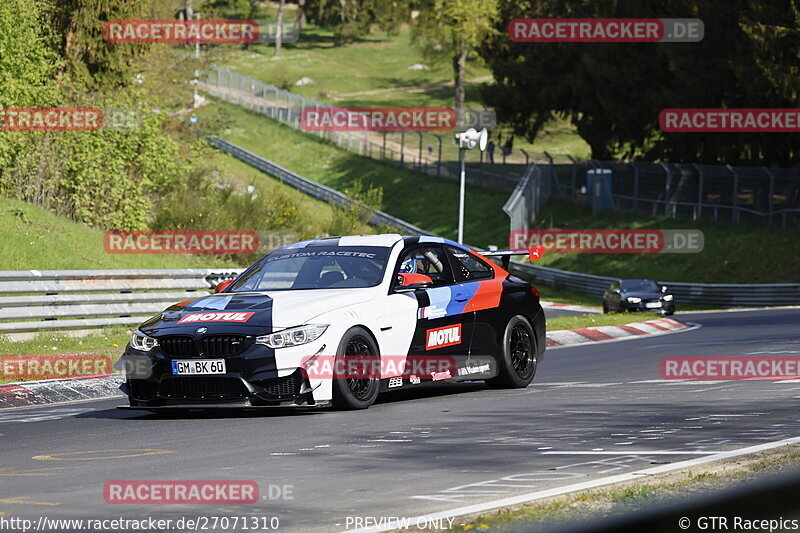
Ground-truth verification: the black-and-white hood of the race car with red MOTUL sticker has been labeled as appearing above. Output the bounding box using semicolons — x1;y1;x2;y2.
139;288;375;335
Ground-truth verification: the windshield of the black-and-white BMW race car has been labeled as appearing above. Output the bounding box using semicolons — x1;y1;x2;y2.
226;246;391;292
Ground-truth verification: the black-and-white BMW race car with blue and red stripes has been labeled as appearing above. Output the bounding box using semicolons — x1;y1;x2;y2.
122;235;546;410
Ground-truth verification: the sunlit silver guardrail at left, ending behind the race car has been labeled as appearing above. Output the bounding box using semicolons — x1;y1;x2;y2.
0;268;242;339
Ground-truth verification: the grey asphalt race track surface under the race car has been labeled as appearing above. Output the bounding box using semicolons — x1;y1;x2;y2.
0;309;800;531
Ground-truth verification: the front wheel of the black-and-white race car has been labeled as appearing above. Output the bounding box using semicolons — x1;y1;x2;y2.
332;327;380;411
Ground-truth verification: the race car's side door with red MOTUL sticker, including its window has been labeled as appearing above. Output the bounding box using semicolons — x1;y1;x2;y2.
396;244;474;355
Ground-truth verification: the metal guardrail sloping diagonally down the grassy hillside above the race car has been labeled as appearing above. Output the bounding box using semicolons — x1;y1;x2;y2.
207;137;433;235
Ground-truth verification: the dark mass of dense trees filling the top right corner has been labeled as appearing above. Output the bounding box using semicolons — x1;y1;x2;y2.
480;0;800;164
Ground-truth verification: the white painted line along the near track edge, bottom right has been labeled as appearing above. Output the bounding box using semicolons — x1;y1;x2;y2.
346;437;800;533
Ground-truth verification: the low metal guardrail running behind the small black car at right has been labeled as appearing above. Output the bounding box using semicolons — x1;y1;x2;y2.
511;261;800;307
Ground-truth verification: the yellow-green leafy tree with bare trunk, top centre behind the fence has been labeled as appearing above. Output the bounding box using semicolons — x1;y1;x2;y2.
412;0;497;122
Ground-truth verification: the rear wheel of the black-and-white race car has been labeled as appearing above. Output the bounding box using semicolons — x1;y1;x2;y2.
486;315;538;389
